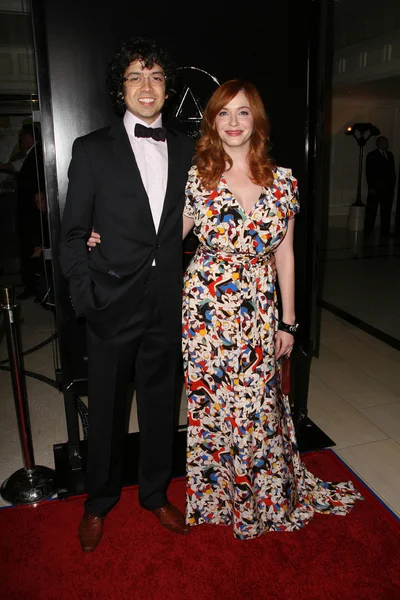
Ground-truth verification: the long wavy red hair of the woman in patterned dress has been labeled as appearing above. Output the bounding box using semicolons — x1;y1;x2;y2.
196;79;274;190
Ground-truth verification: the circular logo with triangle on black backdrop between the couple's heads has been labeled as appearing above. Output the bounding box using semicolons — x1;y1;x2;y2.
168;67;220;139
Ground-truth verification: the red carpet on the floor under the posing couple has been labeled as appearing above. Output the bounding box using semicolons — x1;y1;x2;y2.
0;450;400;600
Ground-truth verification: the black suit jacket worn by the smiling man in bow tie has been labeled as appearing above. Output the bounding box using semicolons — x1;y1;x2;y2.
60;121;193;341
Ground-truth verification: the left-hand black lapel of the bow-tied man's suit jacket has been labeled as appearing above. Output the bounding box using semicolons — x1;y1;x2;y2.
110;120;155;233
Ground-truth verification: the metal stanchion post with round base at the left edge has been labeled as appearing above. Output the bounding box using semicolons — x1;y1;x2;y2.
0;287;57;504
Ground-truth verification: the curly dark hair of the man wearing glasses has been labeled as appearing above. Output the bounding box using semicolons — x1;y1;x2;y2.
107;38;176;115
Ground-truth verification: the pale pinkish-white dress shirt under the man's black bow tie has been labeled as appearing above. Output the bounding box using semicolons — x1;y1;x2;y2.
124;111;168;233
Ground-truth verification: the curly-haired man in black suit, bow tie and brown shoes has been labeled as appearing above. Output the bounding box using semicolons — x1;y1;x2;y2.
60;39;193;551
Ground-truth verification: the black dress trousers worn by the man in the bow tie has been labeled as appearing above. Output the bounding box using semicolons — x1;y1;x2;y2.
85;267;181;515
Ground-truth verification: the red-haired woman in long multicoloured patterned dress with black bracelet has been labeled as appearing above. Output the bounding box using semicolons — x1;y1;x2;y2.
183;80;361;539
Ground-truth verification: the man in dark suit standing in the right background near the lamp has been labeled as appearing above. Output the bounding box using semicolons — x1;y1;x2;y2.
364;136;396;243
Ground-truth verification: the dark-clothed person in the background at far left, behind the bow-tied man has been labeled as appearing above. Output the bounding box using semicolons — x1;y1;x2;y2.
16;125;48;299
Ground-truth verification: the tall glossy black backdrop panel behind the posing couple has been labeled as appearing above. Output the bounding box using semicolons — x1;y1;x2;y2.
32;0;326;424
